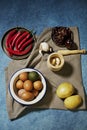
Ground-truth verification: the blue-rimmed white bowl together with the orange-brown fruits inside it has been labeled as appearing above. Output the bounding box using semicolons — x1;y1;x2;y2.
9;68;46;105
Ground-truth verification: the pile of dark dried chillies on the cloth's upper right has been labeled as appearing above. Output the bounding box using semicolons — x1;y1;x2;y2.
51;26;74;49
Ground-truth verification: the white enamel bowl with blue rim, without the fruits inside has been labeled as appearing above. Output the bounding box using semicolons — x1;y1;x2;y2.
9;68;46;105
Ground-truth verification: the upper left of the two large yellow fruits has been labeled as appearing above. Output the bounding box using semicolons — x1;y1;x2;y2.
56;82;75;98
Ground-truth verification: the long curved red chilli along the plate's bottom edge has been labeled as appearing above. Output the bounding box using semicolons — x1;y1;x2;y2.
6;44;33;56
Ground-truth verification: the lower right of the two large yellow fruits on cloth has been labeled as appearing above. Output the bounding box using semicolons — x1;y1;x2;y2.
64;95;82;110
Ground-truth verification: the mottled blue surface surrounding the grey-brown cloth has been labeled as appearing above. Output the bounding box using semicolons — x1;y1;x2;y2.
0;0;87;130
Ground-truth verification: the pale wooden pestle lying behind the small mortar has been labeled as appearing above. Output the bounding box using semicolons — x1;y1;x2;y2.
57;49;87;56
